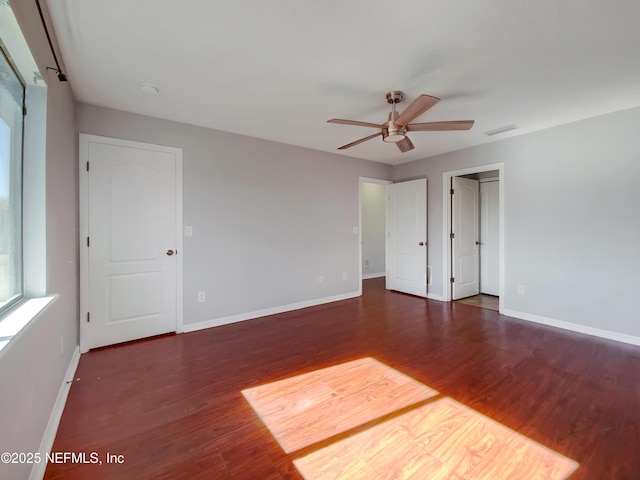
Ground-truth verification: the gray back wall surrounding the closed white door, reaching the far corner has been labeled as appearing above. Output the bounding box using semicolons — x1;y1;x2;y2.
76;104;391;325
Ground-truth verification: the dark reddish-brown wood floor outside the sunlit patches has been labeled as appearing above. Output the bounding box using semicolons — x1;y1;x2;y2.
45;279;640;480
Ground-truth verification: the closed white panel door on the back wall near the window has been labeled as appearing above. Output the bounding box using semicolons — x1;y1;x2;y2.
80;136;182;348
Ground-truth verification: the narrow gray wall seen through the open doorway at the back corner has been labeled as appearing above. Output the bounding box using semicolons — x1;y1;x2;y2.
360;183;387;276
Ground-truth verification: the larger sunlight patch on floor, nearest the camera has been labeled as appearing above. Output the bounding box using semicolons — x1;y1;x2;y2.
293;398;578;480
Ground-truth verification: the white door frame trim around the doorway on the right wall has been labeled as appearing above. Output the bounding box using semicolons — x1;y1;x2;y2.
442;162;505;313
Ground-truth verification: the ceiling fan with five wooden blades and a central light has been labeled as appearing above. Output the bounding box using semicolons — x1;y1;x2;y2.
327;90;474;153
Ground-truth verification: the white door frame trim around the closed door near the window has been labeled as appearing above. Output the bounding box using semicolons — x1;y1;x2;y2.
78;133;184;353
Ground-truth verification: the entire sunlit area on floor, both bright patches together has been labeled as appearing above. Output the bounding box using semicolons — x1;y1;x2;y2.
242;357;579;480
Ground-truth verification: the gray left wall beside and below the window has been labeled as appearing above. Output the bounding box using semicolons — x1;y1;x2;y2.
0;0;78;479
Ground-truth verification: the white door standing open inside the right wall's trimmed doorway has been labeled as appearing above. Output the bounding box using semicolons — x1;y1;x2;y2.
451;177;480;300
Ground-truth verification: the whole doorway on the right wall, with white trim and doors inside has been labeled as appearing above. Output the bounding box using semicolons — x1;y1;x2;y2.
443;164;504;311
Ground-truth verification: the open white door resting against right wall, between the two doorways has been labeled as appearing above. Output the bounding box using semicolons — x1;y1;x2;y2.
386;179;427;297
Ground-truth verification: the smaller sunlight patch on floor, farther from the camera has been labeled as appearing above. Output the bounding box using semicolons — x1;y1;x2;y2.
242;357;438;453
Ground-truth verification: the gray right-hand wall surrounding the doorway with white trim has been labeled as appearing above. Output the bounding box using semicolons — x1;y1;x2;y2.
394;108;640;337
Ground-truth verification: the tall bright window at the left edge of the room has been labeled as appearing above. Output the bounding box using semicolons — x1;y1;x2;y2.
0;46;25;312
